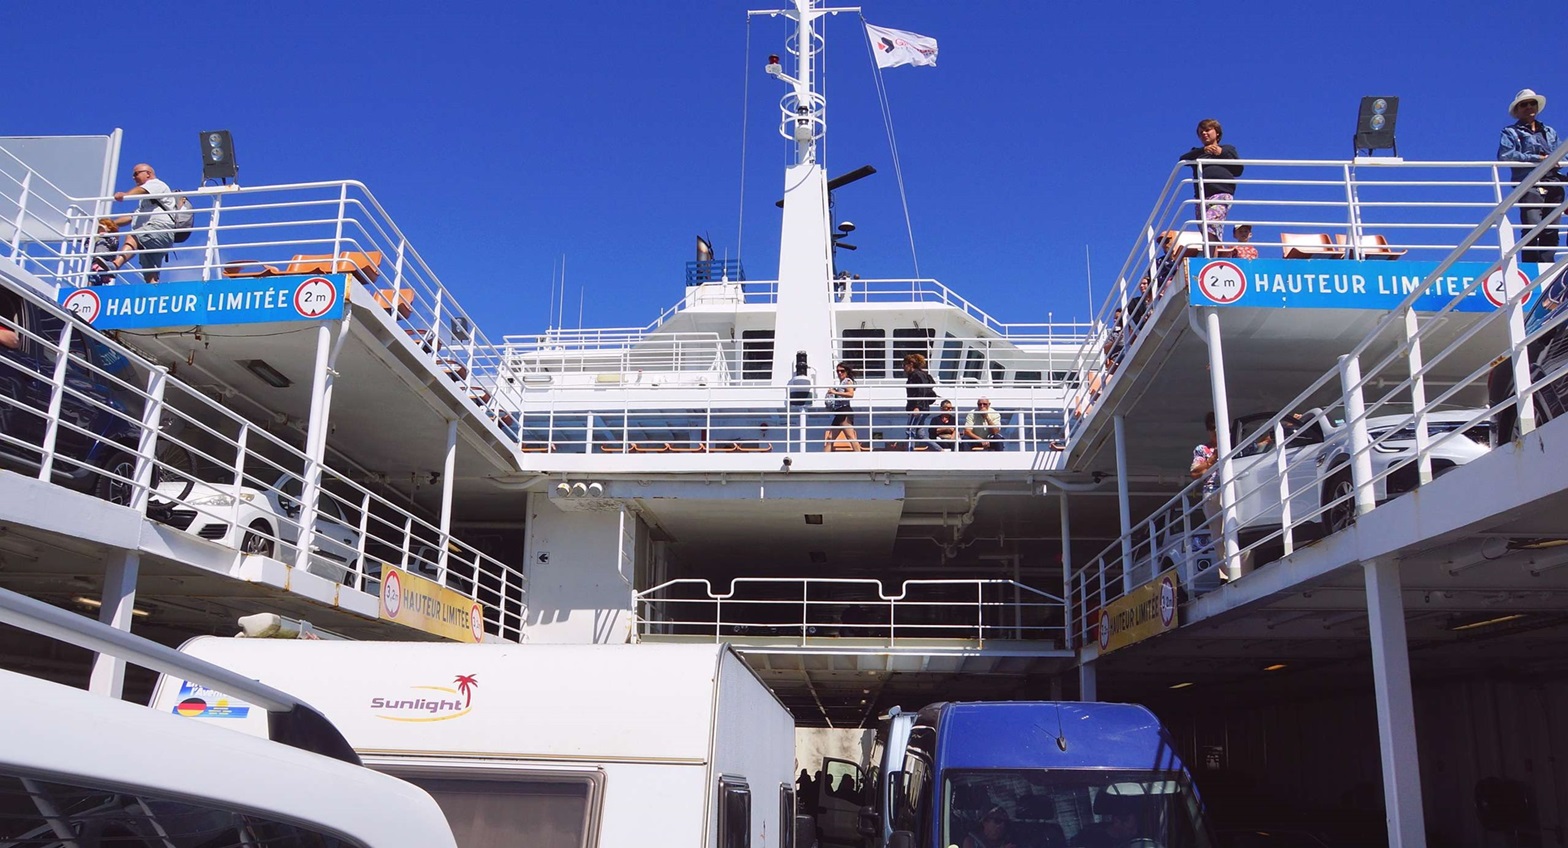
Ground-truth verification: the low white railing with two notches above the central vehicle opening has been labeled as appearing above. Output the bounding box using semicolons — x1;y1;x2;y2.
637;577;1065;647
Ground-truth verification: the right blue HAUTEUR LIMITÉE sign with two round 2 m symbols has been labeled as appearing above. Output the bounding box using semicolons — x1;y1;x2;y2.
1187;259;1537;312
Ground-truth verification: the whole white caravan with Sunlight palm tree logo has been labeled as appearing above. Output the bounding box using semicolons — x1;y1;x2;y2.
154;636;795;848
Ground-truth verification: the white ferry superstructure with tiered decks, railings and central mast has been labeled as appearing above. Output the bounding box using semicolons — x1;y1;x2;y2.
0;0;1568;845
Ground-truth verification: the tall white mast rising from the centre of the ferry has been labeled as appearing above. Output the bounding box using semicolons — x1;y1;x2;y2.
751;0;859;384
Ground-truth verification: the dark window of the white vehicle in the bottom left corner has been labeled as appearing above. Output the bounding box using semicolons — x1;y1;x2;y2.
0;774;370;848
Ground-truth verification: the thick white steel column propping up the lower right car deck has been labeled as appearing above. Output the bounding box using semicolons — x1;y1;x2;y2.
1363;561;1427;848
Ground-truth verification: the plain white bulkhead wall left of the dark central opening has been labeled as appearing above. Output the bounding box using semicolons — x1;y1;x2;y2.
524;492;652;644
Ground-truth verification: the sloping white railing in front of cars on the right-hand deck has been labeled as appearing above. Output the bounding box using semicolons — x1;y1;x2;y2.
1069;144;1568;644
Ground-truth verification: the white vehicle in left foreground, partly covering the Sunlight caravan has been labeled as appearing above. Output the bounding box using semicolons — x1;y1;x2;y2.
0;589;456;848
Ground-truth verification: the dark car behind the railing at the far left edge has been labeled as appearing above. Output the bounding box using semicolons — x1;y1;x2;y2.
0;287;143;505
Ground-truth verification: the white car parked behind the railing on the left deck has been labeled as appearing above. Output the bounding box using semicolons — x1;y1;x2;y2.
149;473;359;583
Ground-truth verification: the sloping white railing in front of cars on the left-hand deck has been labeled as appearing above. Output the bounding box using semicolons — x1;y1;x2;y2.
0;274;525;641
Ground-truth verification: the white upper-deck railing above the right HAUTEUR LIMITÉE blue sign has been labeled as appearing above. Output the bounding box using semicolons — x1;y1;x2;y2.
1068;160;1561;436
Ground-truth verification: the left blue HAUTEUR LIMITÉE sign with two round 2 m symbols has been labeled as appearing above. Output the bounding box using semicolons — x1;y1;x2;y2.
60;274;348;329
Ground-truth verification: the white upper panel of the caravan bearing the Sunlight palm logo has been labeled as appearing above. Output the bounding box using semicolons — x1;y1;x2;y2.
155;636;771;762
